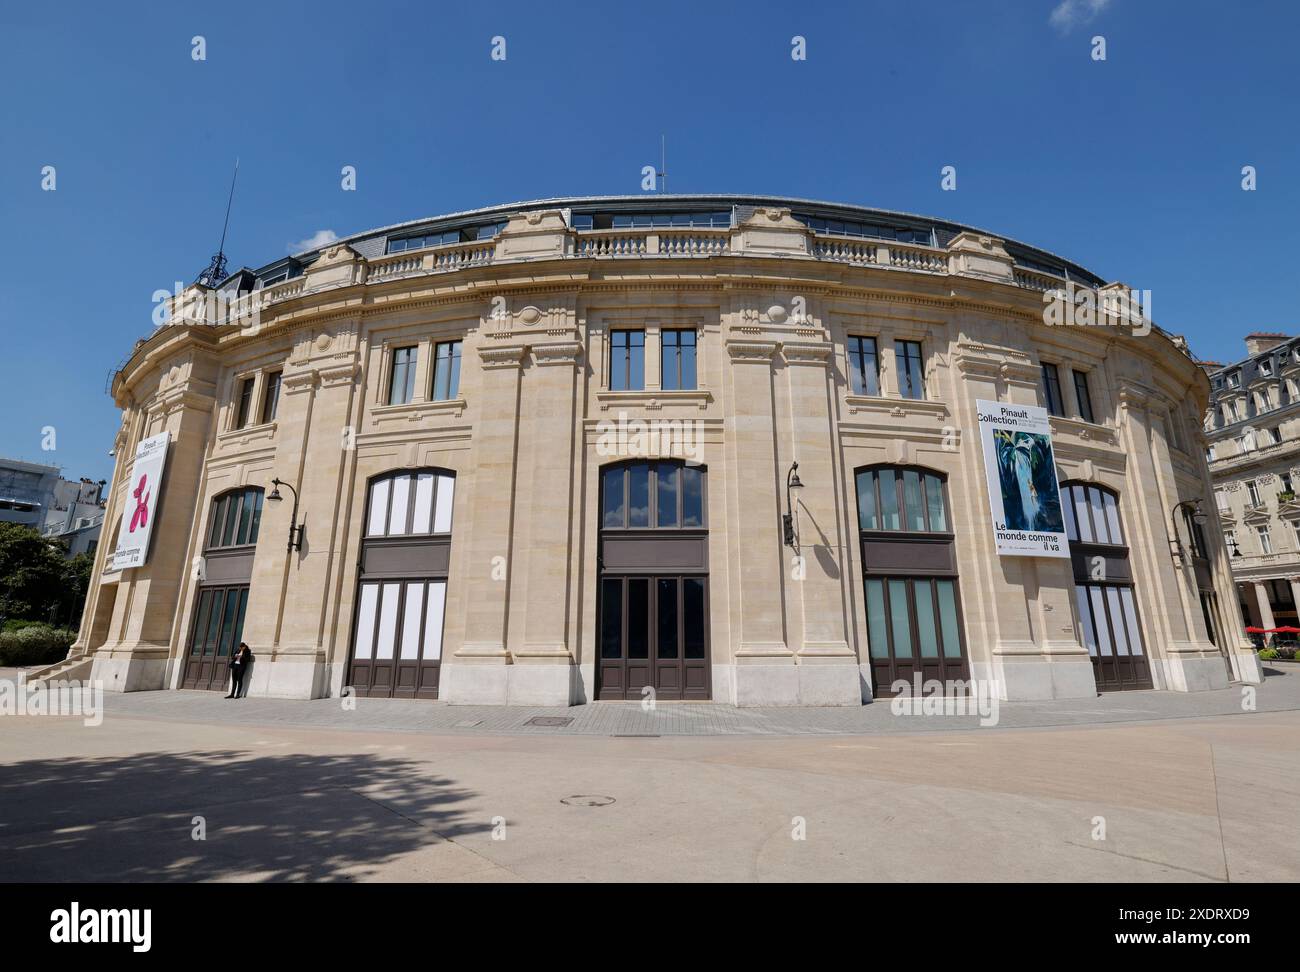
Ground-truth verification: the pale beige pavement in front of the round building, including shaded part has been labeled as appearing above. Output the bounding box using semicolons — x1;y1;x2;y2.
0;676;1300;881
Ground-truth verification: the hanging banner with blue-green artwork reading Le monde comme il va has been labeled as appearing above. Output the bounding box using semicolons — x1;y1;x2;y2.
975;400;1070;557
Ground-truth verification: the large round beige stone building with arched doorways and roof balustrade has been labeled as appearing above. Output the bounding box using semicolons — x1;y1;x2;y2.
61;195;1258;704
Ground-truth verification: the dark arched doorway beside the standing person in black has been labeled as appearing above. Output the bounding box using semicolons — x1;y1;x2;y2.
181;486;263;689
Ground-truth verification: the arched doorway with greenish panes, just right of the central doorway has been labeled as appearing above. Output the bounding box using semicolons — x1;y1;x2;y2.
855;465;970;698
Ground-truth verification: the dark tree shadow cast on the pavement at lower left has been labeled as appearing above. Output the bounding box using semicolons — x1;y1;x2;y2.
0;750;490;881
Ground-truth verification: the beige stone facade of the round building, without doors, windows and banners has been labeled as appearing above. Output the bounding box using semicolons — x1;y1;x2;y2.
74;196;1258;706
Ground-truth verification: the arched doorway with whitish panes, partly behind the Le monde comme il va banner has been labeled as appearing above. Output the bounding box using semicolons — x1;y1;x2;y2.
1061;482;1152;691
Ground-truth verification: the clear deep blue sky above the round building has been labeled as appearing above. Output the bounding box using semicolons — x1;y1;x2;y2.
0;0;1300;478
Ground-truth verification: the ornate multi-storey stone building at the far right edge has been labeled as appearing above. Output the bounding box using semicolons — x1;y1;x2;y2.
1203;333;1300;629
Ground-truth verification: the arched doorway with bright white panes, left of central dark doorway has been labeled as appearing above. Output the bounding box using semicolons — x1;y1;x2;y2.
347;469;456;699
